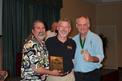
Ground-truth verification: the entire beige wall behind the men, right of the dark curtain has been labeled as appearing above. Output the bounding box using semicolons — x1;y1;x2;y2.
61;0;122;69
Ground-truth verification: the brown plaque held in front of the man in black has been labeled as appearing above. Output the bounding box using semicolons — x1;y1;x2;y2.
50;56;63;72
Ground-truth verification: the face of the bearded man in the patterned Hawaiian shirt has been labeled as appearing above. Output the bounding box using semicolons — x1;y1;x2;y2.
32;21;45;40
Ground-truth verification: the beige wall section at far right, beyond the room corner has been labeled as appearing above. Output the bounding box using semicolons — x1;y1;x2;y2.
96;2;122;68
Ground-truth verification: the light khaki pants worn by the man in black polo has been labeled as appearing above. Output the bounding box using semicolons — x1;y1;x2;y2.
46;72;75;81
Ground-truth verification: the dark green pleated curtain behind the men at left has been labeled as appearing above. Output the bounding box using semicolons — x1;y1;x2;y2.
2;0;61;76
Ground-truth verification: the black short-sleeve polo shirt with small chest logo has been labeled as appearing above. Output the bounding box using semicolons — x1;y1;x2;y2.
45;36;76;72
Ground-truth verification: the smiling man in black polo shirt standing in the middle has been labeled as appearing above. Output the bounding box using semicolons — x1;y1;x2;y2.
46;20;76;81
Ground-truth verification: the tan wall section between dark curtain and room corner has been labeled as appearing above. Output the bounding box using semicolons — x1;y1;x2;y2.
61;0;96;35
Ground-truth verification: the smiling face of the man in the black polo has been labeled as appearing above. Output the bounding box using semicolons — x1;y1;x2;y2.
57;21;71;37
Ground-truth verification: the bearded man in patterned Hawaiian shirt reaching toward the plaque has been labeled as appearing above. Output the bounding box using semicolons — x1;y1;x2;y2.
21;20;59;81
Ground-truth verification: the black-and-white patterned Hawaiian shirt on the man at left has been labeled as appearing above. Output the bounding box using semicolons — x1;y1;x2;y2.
21;35;49;81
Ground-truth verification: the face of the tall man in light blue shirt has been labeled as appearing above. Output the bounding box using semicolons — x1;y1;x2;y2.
76;17;90;35
